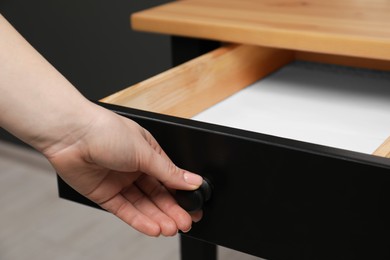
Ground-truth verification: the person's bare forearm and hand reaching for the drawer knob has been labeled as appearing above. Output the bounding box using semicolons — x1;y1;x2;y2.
0;15;202;236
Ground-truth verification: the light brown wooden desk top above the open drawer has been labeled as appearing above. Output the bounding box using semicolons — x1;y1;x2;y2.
131;0;390;60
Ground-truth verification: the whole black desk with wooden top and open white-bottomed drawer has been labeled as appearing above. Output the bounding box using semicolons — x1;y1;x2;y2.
59;0;390;260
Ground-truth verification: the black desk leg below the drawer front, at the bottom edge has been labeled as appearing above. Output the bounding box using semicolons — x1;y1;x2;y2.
180;235;217;260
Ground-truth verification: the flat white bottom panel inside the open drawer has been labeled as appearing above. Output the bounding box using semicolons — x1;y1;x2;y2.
193;62;390;154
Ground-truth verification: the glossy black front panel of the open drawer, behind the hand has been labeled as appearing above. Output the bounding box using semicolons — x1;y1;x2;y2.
59;104;390;260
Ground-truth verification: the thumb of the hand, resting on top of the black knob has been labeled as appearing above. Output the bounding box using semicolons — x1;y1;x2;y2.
139;141;203;190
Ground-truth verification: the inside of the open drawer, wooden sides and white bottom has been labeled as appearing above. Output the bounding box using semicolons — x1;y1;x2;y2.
101;45;390;157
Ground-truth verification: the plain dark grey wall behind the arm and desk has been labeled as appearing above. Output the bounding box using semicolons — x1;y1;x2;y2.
0;0;171;146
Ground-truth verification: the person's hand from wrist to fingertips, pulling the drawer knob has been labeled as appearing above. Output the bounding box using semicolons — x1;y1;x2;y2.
43;104;202;236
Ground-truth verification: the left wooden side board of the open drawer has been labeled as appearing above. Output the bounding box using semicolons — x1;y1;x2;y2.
101;45;294;118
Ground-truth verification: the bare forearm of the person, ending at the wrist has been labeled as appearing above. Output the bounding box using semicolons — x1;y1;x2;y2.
0;15;93;151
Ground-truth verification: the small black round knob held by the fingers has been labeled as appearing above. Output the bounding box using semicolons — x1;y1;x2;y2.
175;179;212;211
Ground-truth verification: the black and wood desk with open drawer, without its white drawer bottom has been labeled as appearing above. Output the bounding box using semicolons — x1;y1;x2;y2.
59;0;390;260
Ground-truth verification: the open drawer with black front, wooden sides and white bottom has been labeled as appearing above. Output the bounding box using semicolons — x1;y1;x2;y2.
59;45;390;259
